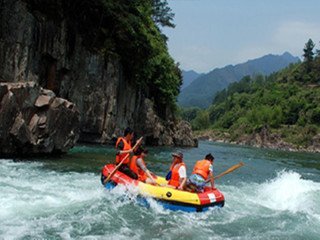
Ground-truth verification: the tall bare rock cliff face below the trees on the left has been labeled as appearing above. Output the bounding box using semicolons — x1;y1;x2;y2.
0;0;198;149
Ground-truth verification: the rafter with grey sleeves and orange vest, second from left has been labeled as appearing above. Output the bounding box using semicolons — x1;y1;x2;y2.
130;147;157;184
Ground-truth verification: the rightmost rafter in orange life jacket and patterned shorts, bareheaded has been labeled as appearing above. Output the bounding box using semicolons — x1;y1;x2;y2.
186;153;215;192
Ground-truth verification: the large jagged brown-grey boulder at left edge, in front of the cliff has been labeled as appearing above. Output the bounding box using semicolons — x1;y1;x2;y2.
0;82;80;158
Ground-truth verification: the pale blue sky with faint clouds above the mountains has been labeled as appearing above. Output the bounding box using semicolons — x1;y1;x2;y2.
162;0;320;73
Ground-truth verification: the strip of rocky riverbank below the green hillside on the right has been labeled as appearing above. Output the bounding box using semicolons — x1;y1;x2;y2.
197;126;320;153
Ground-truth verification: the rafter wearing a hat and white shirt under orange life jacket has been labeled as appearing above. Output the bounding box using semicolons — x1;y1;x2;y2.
160;151;187;190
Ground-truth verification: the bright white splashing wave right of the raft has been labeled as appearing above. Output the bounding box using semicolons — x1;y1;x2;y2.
225;170;320;218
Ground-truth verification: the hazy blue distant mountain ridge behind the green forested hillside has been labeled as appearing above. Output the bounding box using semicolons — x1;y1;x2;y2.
178;52;300;108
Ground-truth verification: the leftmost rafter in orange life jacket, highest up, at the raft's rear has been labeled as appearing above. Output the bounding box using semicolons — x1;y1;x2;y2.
116;127;138;179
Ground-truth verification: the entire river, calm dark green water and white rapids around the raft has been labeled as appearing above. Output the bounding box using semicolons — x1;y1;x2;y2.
0;141;320;240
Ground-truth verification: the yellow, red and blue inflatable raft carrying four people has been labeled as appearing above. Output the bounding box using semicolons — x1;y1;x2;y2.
105;164;224;212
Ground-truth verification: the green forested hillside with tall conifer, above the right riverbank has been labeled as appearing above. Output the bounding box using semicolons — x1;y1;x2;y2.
181;40;320;151
